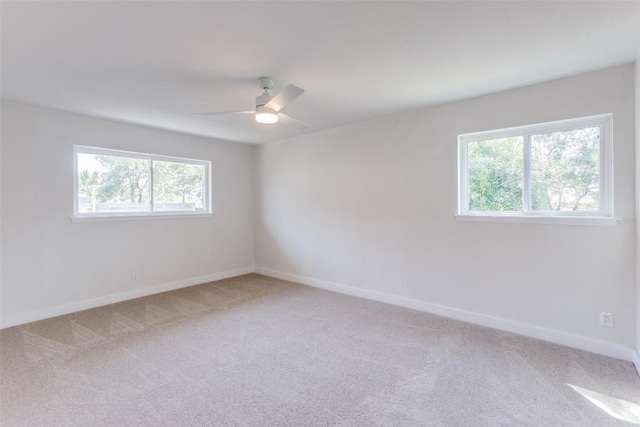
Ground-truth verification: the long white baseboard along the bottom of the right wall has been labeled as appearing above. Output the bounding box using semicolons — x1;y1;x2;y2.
255;267;640;367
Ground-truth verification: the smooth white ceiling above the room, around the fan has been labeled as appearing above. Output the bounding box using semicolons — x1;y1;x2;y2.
0;1;640;143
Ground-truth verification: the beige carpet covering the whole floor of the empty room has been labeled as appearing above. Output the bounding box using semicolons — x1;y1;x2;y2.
0;274;640;427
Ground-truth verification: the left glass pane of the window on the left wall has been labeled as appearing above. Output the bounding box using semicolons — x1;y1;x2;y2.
78;153;150;214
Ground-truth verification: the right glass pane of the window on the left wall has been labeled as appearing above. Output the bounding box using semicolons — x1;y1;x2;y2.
153;161;205;212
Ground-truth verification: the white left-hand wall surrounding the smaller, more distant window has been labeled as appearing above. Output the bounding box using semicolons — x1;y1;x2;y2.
1;101;253;326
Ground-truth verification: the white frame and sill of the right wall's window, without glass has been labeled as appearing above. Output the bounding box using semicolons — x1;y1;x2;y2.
456;114;617;225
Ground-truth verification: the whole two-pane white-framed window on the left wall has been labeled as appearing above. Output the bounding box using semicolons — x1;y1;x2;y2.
74;146;211;218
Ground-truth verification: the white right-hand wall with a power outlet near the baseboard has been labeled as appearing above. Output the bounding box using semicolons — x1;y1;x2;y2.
256;65;636;359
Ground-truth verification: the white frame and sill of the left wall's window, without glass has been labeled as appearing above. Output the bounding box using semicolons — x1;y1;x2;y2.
71;145;213;222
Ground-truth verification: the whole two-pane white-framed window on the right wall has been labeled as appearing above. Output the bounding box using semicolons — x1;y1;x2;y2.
458;114;615;223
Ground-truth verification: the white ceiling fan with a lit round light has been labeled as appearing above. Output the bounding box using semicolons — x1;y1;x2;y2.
197;77;309;128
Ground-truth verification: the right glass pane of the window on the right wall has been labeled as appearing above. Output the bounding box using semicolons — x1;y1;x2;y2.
531;127;600;211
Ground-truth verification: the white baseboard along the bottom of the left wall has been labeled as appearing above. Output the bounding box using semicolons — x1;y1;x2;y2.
0;266;255;329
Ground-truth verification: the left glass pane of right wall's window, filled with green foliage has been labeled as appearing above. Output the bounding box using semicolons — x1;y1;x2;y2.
467;137;523;212
